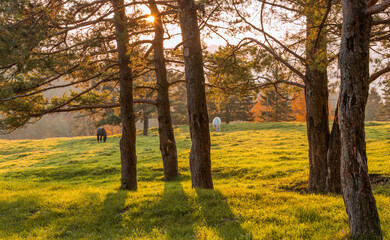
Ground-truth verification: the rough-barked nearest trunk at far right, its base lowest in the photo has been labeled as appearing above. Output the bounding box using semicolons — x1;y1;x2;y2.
339;0;382;239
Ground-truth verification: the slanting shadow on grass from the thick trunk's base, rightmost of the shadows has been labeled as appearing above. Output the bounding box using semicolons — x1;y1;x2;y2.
196;189;253;240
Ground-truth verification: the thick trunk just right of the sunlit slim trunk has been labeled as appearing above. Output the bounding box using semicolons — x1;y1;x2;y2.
179;0;213;188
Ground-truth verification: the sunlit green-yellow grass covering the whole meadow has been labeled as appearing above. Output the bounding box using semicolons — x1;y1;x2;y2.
0;123;390;240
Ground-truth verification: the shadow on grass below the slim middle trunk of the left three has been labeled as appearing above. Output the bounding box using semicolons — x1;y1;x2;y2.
140;181;196;239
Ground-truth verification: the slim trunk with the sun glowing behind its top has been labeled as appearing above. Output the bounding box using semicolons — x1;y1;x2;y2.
149;0;179;181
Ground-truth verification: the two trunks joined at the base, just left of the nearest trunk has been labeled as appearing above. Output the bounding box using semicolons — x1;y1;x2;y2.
305;1;341;194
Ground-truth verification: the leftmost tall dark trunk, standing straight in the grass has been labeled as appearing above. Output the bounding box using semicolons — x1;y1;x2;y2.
111;0;137;190
